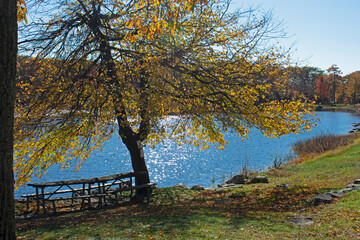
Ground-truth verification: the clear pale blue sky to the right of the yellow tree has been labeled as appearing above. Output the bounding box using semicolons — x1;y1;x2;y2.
232;0;360;75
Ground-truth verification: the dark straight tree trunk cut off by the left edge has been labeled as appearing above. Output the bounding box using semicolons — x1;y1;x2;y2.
0;0;17;239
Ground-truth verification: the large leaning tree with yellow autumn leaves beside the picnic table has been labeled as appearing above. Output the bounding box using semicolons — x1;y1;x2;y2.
16;0;312;194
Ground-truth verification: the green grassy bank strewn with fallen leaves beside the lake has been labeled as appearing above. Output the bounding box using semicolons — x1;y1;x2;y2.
17;140;360;239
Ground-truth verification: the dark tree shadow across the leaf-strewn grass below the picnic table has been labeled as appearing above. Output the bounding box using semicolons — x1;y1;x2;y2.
17;186;317;239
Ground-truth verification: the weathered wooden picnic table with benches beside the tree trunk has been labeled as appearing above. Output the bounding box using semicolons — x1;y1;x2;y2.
21;172;156;213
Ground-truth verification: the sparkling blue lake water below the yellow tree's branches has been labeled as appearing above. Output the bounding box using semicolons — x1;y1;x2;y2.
15;112;359;198
